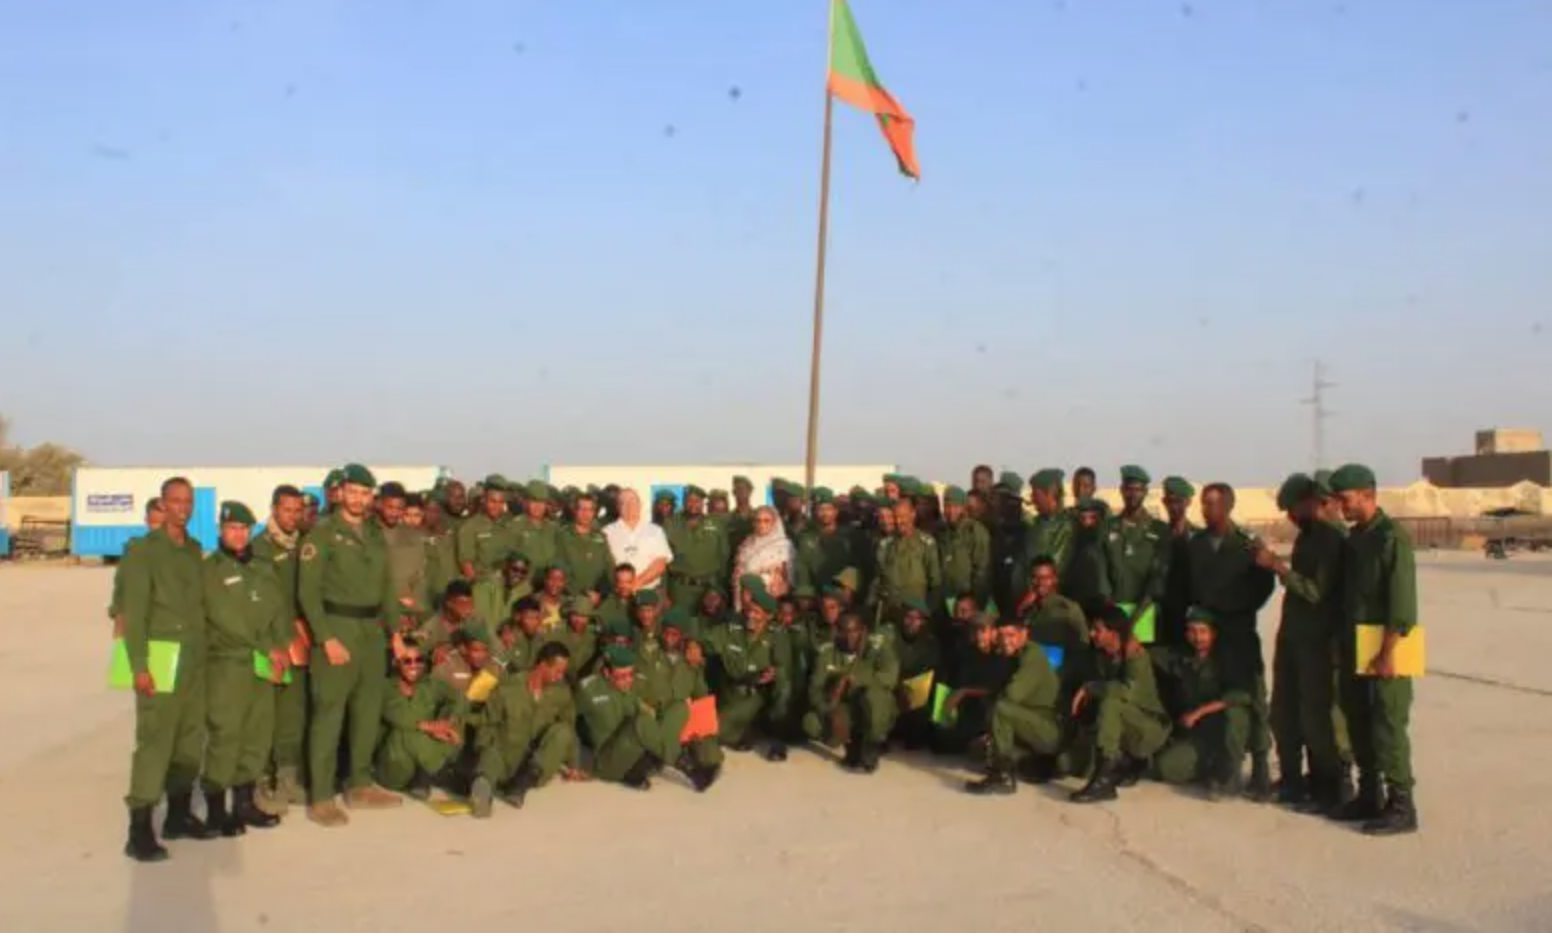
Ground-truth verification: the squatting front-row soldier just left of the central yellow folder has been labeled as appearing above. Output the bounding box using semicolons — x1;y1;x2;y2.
802;613;900;773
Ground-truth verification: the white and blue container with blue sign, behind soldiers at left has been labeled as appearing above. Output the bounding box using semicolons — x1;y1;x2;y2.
70;466;445;556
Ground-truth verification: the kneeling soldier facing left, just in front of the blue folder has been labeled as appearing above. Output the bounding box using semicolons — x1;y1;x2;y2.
951;618;1062;795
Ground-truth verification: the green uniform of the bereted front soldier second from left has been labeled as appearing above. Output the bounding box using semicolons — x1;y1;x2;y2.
203;537;293;792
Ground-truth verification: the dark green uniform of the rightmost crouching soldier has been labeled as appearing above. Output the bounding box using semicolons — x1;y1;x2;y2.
1153;647;1254;784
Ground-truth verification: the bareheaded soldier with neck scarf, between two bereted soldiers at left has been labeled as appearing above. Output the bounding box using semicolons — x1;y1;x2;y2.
253;484;309;815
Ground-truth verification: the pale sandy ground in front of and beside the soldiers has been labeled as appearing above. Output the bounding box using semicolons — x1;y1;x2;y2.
0;556;1552;931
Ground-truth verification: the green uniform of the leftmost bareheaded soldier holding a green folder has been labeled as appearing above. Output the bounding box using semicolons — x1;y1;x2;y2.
120;529;206;809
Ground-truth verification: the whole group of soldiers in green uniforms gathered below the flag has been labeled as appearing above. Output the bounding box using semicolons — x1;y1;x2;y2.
109;464;1417;860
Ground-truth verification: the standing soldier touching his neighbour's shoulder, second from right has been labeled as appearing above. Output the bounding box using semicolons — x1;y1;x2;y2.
1256;473;1349;812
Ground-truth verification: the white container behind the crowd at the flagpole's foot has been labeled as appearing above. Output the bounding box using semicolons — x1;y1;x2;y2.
545;464;897;503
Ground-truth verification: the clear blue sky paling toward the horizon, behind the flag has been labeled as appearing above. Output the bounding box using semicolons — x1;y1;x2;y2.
0;0;1552;483
